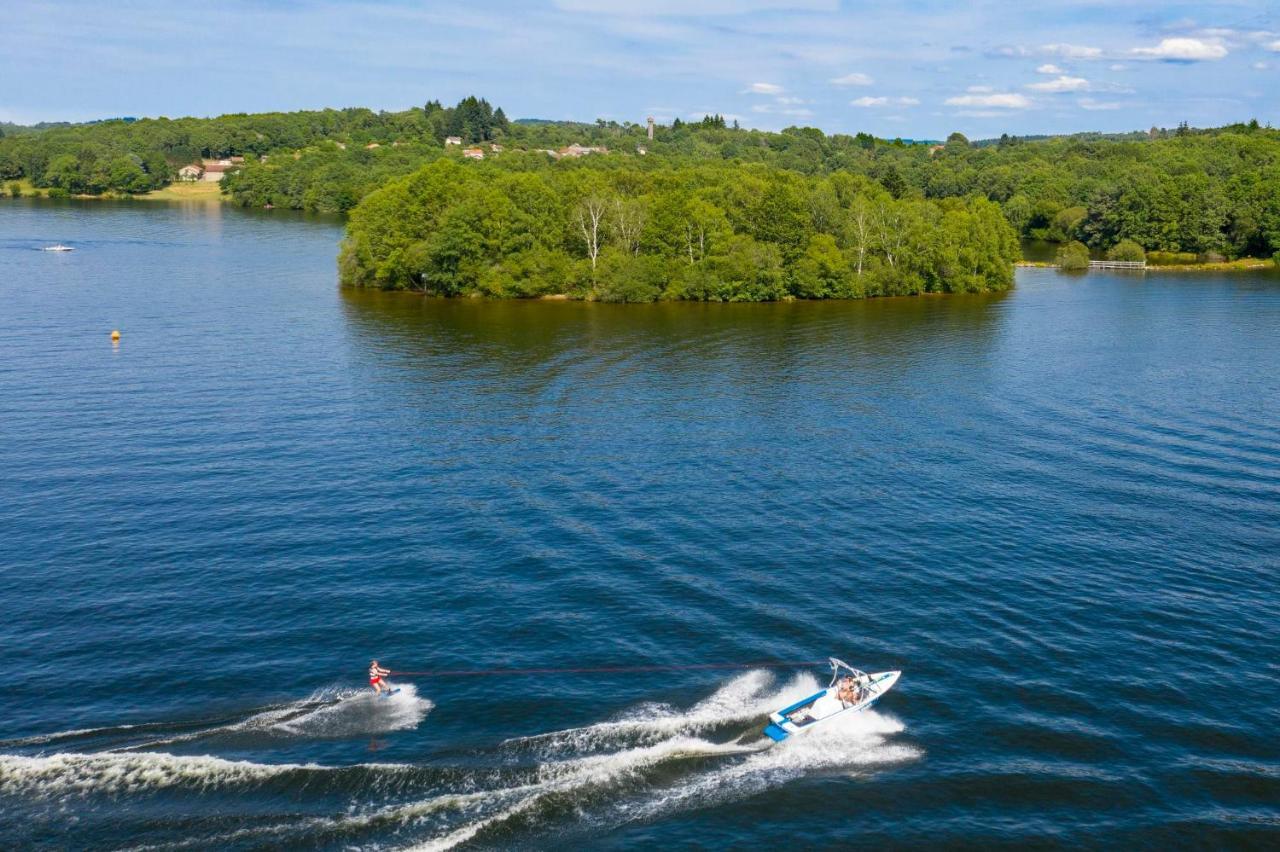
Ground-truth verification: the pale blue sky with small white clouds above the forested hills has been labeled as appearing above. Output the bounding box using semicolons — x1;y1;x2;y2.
0;0;1280;138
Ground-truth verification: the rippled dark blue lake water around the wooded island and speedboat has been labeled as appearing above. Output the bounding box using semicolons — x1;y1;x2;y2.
0;200;1280;849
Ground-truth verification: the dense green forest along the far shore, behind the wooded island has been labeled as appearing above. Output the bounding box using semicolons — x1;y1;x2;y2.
0;97;1280;266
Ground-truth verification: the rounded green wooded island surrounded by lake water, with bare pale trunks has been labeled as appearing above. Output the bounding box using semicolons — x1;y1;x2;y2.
339;157;1019;302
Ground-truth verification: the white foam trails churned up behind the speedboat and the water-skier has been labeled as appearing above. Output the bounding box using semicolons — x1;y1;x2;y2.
0;672;920;849
